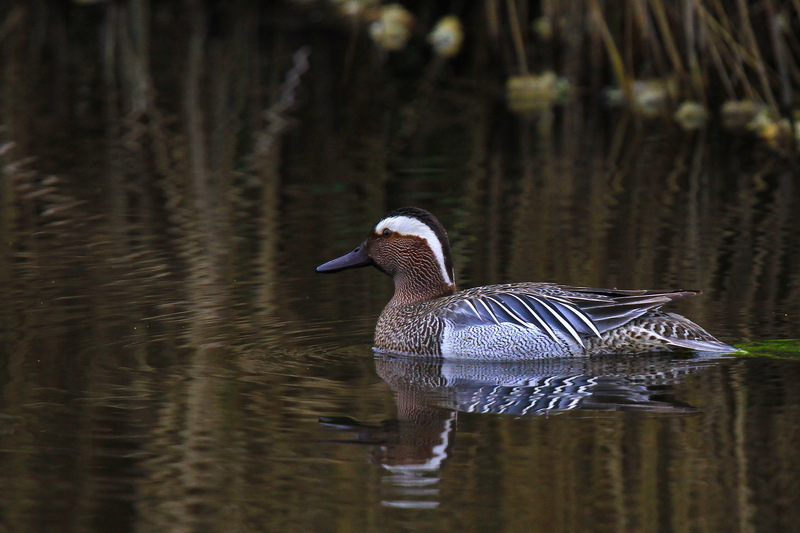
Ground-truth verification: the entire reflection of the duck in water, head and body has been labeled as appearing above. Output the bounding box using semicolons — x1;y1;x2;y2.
320;352;714;508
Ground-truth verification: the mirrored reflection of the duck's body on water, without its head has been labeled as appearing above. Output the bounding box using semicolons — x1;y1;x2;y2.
375;352;711;416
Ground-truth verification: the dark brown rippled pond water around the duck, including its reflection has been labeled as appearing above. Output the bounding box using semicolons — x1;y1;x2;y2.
0;4;800;532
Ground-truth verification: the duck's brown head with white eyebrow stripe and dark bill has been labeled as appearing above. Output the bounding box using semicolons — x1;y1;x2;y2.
317;207;456;303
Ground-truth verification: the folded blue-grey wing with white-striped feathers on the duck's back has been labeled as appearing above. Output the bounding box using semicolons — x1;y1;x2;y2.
437;284;699;346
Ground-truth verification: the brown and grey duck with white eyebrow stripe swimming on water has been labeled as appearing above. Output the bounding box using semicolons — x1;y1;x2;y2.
316;207;735;360
